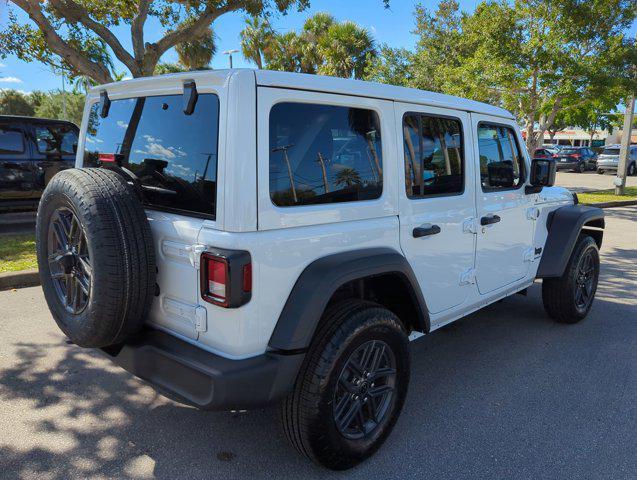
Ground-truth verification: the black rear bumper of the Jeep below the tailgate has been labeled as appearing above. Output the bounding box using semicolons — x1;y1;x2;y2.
102;329;305;410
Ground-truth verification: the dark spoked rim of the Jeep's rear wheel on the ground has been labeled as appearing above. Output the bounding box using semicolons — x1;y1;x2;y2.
332;340;396;440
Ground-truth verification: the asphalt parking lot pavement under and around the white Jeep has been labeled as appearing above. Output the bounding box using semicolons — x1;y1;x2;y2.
0;207;637;480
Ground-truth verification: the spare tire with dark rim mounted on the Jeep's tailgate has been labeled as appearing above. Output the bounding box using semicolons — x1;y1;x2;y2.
36;168;157;347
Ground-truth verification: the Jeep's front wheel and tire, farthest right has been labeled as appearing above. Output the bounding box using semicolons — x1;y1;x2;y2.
542;235;599;323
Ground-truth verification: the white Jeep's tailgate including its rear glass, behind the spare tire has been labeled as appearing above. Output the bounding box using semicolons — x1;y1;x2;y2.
85;88;220;340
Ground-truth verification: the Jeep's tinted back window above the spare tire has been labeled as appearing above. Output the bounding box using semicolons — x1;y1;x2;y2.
85;94;219;216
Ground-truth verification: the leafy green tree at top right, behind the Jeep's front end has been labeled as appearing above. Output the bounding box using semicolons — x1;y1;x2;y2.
367;0;637;151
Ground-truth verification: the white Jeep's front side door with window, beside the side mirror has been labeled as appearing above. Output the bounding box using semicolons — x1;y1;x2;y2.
472;115;536;295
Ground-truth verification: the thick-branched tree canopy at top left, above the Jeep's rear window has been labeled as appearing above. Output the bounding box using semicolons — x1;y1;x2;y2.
0;0;309;83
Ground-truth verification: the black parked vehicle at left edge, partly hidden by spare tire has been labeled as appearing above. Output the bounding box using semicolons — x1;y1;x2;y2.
0;115;79;211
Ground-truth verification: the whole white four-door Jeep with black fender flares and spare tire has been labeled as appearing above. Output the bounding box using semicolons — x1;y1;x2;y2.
37;70;604;469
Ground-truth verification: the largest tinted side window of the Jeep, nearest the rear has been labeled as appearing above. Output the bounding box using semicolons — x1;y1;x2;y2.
270;103;383;206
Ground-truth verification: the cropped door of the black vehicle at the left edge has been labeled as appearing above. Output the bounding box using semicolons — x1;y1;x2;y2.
0;120;34;201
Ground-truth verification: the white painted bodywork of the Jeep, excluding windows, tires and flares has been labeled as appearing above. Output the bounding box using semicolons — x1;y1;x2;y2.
76;70;572;359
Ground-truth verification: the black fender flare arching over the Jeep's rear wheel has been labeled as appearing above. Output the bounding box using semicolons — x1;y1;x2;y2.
268;248;429;351
